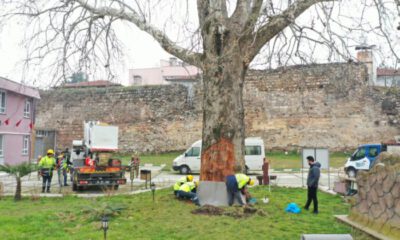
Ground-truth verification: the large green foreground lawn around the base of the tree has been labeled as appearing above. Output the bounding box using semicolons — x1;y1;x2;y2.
0;187;364;239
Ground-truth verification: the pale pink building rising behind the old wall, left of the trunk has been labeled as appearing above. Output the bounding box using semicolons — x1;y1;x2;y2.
129;58;201;86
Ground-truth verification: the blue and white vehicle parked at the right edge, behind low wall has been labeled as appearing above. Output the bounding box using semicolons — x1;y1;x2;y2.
344;141;400;178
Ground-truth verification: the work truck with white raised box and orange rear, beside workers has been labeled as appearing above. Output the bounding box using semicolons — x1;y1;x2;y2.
71;121;126;191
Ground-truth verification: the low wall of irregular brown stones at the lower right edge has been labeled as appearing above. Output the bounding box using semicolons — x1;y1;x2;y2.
350;154;400;239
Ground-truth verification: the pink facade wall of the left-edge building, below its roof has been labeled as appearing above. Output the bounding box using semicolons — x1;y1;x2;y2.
0;91;34;164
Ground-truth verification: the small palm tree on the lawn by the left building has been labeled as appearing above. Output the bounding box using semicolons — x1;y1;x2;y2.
0;163;35;201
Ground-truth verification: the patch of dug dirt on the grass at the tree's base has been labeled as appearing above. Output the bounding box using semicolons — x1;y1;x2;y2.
192;205;266;218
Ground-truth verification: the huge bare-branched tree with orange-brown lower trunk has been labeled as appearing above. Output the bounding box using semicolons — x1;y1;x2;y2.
0;0;400;184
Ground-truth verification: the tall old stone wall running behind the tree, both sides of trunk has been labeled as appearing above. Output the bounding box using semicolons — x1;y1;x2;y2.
36;64;400;152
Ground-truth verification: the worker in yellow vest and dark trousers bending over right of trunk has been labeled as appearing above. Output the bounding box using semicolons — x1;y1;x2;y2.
225;173;254;206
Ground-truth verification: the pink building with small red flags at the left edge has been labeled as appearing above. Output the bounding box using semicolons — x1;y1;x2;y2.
0;77;40;164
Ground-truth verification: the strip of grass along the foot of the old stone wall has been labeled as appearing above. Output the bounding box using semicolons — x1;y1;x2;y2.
116;151;349;171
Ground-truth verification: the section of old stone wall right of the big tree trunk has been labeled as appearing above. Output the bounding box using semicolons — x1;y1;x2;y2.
244;64;400;150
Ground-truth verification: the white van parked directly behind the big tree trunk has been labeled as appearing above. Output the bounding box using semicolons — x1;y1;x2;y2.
172;137;265;174
